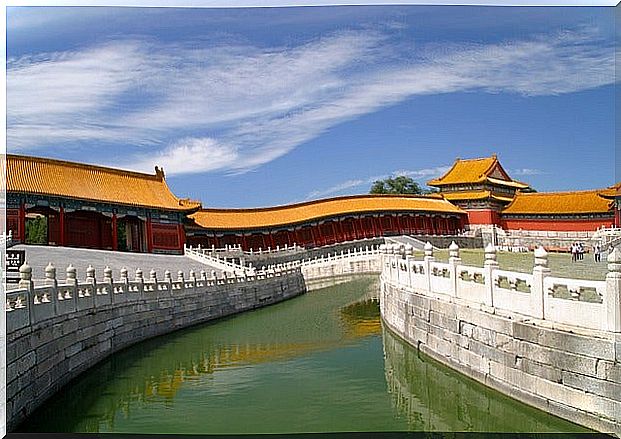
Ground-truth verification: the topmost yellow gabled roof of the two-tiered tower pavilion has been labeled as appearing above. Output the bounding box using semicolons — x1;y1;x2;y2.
427;155;528;189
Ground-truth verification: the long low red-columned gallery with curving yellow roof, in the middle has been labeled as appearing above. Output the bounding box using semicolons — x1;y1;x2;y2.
186;195;466;249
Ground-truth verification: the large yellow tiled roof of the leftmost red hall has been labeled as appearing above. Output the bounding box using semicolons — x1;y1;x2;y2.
6;154;200;211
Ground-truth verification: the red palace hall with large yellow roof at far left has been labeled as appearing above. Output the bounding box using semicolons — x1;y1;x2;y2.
6;154;200;253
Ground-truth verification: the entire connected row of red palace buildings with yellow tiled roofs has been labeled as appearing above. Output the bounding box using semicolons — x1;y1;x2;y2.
6;154;621;254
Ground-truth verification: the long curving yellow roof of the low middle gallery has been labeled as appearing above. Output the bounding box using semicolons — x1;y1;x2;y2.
190;195;464;230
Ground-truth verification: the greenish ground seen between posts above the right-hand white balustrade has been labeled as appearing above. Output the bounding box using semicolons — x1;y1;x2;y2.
414;249;608;280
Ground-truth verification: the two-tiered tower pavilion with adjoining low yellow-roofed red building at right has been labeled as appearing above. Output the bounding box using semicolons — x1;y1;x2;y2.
427;155;621;232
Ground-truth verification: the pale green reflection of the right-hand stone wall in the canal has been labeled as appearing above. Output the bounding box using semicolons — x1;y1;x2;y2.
382;329;589;432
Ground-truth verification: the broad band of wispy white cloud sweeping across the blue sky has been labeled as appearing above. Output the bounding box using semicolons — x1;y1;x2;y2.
7;29;614;175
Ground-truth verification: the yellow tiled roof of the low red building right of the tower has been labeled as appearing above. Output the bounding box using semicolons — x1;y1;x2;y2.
502;190;610;214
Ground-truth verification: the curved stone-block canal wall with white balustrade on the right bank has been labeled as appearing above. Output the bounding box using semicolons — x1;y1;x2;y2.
380;246;621;436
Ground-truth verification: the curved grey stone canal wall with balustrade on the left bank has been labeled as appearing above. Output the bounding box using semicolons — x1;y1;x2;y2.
6;267;306;431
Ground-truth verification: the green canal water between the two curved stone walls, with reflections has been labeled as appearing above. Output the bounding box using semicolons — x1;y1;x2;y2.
18;278;583;434
